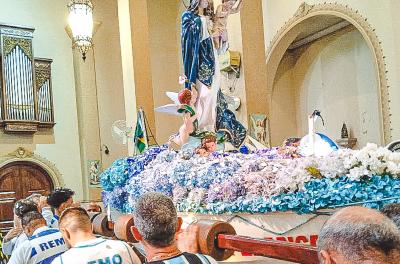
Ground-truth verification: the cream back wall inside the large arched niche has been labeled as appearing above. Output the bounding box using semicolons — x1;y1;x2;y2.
293;29;383;147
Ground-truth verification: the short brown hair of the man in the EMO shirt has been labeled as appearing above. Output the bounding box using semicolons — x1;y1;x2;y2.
59;207;92;231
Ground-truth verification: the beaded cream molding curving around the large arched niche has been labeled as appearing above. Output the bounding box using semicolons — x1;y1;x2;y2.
266;2;392;144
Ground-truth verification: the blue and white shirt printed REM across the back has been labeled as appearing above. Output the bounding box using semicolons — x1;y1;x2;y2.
8;226;68;264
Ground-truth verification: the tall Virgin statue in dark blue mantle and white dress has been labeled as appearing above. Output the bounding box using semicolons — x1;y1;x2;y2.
181;0;246;148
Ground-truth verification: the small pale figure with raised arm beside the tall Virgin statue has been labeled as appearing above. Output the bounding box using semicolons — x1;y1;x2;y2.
213;0;243;53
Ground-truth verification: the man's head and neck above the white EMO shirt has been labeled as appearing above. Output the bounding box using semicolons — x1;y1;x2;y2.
58;207;93;247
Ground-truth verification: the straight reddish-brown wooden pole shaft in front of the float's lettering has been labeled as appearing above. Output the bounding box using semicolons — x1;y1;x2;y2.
217;234;319;264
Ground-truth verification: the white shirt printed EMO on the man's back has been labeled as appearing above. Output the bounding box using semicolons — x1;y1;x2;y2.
52;238;141;264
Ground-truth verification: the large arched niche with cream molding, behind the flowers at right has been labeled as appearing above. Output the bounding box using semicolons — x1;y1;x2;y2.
267;3;391;145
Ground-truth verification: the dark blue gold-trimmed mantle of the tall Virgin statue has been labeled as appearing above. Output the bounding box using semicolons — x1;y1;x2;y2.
181;11;247;148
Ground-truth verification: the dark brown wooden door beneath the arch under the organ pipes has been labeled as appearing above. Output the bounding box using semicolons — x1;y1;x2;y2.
0;162;54;233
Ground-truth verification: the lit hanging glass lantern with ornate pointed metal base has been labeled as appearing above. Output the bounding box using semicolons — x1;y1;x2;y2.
68;0;93;61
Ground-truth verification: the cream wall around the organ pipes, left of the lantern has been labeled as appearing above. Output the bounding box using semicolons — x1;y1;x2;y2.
0;0;83;198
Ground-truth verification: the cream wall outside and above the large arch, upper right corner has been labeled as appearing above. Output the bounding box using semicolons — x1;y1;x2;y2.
263;0;400;143
